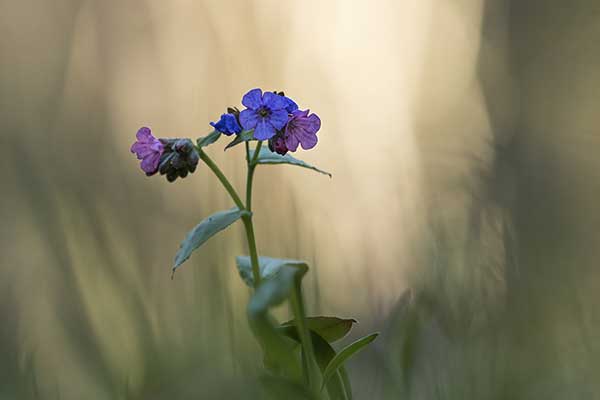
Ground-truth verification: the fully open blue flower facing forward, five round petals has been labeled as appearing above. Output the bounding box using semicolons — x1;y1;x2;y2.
240;89;288;140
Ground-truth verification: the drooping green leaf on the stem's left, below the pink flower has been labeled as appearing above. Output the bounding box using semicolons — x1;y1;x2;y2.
173;207;250;273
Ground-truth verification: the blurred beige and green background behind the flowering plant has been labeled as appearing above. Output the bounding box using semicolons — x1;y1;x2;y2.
0;0;600;400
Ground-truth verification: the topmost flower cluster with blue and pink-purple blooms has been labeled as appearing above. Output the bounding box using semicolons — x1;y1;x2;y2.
211;89;321;155
